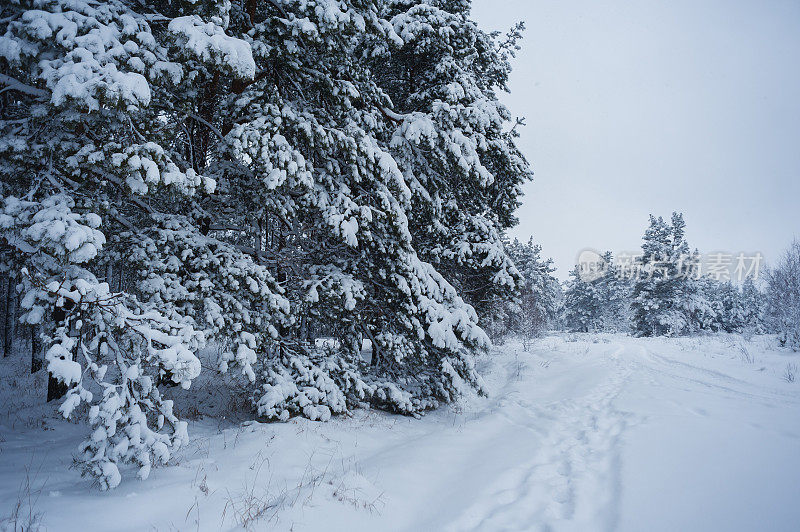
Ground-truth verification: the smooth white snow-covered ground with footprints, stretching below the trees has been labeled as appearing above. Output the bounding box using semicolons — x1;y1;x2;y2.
0;335;800;531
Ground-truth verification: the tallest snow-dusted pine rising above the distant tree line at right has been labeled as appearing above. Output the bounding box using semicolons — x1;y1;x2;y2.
631;213;708;336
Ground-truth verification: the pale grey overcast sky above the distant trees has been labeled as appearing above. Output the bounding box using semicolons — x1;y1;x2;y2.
473;0;800;279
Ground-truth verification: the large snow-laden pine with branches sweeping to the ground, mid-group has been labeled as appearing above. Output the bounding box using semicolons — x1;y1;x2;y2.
213;1;510;418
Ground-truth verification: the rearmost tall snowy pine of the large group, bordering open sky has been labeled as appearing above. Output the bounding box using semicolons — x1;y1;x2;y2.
374;0;531;319
